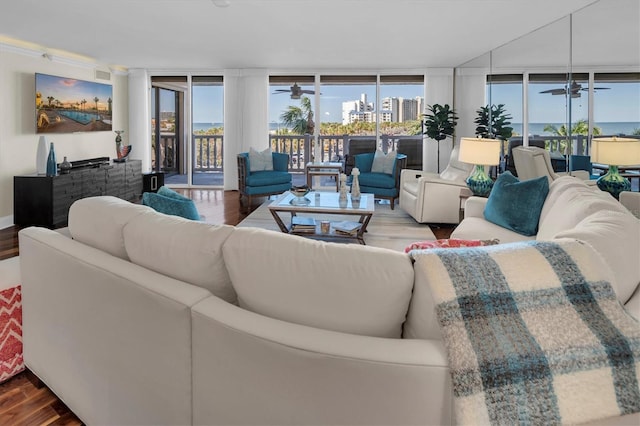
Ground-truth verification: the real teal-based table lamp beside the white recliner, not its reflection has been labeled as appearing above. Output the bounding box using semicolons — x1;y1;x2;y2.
458;138;502;197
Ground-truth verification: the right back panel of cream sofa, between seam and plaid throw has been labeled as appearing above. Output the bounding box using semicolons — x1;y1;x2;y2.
192;296;452;425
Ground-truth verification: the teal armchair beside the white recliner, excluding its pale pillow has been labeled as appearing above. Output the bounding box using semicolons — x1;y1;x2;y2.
349;152;407;210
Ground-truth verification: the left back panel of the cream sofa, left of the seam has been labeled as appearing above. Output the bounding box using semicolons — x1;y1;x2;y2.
19;227;211;424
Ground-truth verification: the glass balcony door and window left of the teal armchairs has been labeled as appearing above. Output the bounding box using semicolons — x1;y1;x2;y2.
151;75;224;186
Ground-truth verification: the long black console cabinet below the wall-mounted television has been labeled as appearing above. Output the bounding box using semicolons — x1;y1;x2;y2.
13;160;142;228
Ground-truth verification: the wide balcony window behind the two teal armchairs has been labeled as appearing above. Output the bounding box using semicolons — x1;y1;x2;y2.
269;75;424;166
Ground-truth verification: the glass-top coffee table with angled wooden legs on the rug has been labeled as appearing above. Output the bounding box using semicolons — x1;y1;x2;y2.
269;191;374;244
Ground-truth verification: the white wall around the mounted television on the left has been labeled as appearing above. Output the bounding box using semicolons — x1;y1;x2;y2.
0;46;129;229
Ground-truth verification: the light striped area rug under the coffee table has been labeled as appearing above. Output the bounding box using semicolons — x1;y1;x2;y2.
238;200;436;251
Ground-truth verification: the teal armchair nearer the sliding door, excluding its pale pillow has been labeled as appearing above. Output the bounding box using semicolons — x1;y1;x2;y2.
238;152;291;209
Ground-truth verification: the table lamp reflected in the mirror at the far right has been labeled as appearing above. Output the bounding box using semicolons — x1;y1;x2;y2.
591;136;640;199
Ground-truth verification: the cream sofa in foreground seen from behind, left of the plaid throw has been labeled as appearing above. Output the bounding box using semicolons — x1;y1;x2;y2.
19;188;640;425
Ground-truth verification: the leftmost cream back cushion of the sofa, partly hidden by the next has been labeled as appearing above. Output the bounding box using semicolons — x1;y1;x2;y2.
69;196;153;260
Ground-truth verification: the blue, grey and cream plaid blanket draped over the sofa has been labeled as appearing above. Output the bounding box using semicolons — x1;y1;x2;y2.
414;240;640;425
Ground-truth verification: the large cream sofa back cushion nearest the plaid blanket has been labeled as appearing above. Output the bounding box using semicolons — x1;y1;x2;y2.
222;228;413;337
